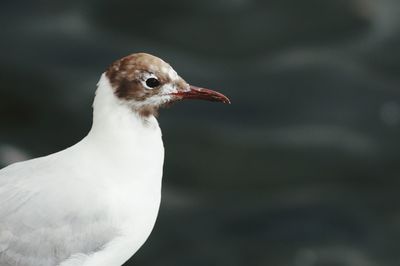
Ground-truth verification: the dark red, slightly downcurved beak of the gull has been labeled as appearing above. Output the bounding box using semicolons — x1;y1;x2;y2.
173;86;231;104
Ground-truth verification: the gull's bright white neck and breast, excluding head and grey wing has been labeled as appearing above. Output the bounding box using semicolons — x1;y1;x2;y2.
62;74;164;266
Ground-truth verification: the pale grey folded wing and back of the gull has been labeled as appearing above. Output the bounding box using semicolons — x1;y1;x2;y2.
0;159;118;266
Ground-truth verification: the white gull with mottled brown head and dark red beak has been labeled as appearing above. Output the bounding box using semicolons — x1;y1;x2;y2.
0;53;230;266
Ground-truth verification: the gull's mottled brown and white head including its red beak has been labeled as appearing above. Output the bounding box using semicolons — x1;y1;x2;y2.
106;53;230;116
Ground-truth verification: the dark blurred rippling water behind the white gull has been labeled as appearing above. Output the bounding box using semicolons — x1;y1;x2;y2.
0;0;400;266
